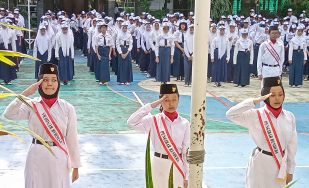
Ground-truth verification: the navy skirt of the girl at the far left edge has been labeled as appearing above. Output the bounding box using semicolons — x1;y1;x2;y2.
0;43;17;81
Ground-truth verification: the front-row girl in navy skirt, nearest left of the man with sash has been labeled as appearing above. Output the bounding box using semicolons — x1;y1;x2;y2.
233;29;253;87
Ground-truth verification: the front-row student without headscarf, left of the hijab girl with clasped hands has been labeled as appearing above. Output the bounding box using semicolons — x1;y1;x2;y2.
95;23;114;85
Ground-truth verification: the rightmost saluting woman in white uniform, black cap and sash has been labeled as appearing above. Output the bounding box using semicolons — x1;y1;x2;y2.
226;77;297;188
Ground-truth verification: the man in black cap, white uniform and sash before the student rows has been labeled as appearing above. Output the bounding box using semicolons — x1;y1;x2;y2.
257;26;284;86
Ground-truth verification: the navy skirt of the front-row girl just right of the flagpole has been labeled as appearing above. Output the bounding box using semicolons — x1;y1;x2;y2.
211;48;227;82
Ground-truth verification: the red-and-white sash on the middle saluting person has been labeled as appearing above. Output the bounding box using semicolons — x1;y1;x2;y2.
153;114;185;179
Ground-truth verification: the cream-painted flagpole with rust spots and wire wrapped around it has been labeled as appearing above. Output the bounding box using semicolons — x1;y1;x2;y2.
188;0;211;188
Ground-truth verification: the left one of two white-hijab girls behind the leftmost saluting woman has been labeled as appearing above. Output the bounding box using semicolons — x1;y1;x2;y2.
33;25;51;79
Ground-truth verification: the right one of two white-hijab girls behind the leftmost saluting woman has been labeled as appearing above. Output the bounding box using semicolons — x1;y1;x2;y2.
55;24;74;85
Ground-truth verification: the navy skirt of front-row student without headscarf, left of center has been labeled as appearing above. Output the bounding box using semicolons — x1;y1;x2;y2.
96;46;110;82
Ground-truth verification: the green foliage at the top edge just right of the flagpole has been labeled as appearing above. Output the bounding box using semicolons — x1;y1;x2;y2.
211;0;232;22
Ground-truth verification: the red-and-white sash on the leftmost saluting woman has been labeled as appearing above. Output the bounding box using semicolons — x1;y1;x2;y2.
32;101;68;155
